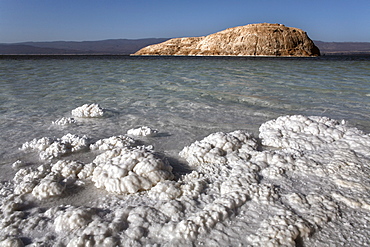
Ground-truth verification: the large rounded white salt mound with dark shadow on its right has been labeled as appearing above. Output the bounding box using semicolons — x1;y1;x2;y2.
92;148;173;194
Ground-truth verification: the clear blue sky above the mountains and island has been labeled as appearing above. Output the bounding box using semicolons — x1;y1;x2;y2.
0;0;370;43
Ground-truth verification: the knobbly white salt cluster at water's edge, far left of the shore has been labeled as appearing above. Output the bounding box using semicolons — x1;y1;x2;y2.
21;134;89;160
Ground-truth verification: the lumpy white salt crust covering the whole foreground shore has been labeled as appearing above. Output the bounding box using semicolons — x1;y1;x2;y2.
0;111;370;246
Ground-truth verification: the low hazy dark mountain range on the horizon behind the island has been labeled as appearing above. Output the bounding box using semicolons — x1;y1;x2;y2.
0;38;370;55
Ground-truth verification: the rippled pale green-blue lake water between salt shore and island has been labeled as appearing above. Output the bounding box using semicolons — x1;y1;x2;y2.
0;57;370;155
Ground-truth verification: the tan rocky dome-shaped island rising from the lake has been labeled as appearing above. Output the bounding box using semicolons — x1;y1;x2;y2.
134;23;320;57
